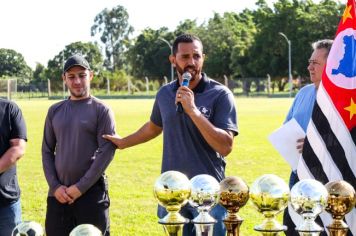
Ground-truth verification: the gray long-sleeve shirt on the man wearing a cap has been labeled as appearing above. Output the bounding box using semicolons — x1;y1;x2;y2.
42;97;116;196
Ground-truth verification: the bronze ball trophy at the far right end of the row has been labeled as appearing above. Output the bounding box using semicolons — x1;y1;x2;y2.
325;180;356;236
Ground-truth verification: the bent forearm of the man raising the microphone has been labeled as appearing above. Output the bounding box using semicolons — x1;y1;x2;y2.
188;108;233;156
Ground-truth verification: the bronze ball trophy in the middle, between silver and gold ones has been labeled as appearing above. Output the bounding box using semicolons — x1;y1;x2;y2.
220;176;249;236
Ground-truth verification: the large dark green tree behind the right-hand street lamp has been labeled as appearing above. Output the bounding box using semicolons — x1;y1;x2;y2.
247;0;341;90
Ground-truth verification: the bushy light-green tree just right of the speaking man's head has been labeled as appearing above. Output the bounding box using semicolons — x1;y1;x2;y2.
198;12;256;78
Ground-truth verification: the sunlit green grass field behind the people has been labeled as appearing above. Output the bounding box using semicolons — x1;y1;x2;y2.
17;98;292;236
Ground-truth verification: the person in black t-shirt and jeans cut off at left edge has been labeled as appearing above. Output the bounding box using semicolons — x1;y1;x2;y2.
0;99;27;236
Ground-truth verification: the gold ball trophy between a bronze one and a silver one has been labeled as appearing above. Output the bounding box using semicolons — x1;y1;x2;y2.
250;174;289;236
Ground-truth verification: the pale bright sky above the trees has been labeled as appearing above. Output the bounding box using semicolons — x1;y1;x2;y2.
0;0;275;69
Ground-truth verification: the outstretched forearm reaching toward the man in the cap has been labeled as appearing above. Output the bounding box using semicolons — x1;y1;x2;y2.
122;121;162;149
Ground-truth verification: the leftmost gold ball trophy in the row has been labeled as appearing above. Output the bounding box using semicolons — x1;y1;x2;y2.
154;171;191;236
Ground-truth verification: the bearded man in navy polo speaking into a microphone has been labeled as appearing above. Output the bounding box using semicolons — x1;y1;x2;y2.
104;34;238;236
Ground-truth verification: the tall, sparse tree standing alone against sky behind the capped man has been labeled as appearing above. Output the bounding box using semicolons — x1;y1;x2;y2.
91;5;134;71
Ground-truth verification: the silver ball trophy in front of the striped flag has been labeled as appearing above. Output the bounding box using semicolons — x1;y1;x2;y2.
290;179;328;236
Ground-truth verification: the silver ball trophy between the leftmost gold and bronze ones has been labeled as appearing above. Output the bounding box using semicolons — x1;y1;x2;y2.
189;174;220;236
